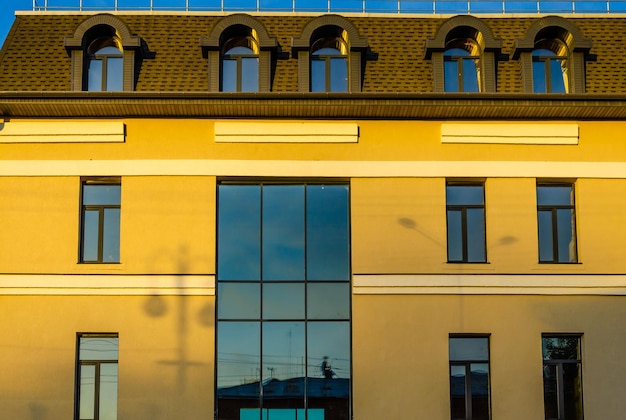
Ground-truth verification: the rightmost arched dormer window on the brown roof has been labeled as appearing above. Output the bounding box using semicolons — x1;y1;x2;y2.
513;16;591;93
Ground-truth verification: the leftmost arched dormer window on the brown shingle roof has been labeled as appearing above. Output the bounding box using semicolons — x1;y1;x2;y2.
65;14;141;91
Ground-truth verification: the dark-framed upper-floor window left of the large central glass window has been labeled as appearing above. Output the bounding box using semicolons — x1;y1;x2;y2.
80;180;121;263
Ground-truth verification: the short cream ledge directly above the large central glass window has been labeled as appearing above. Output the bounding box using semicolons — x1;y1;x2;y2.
215;121;359;143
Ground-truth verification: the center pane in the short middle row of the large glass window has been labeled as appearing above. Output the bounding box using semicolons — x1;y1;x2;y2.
263;283;304;319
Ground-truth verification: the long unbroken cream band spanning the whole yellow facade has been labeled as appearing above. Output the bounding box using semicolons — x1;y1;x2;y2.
0;159;626;179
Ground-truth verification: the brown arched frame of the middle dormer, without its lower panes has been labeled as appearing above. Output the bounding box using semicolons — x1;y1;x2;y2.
291;15;368;93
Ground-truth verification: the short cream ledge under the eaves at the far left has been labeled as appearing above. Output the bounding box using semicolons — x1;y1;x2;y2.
0;121;124;143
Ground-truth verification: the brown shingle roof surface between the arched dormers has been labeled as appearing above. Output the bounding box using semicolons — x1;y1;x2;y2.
0;13;626;94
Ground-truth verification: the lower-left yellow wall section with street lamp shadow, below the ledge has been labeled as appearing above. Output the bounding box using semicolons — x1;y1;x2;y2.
0;296;215;420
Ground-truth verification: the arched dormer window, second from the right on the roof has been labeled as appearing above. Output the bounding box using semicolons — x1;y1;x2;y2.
426;16;502;92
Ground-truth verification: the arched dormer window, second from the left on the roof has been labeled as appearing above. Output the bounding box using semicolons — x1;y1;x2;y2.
200;14;277;92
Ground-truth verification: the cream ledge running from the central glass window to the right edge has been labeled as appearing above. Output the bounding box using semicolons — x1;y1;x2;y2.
352;274;626;296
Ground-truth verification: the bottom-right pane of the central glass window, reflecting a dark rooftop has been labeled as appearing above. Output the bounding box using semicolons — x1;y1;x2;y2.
307;322;350;420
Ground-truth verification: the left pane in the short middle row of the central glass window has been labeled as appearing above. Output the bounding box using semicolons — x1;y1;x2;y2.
217;282;261;319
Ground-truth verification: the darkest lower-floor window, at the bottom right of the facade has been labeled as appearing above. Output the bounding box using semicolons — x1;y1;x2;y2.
541;334;583;420
